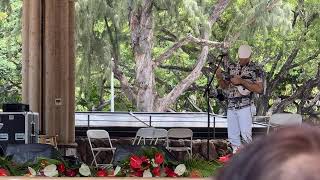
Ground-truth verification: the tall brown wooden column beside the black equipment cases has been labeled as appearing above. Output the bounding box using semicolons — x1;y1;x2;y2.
22;0;75;144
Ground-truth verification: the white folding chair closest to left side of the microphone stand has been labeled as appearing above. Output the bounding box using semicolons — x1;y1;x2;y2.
166;128;193;157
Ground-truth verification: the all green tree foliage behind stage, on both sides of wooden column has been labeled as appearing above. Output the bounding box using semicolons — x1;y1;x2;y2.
0;0;320;116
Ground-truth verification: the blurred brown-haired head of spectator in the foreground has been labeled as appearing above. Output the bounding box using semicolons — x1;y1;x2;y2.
215;125;320;180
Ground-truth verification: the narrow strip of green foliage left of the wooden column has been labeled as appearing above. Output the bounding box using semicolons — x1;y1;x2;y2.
0;0;22;104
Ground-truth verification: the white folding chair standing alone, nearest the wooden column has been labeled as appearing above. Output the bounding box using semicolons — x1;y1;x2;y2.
87;129;116;167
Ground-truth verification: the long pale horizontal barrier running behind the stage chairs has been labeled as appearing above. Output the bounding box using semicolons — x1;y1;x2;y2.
75;112;227;128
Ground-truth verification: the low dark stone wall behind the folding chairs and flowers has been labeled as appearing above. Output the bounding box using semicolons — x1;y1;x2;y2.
76;137;230;164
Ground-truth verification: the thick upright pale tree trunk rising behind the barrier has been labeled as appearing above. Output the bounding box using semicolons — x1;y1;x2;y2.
130;0;155;112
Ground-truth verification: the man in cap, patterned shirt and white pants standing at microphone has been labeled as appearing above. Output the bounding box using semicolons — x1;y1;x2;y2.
216;45;263;152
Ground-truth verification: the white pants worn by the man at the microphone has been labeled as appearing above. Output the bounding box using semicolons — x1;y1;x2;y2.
227;106;252;148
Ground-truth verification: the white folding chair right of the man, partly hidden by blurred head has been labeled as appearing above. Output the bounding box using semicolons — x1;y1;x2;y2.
267;113;302;134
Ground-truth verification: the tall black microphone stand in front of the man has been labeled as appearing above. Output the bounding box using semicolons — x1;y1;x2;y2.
203;53;227;161
